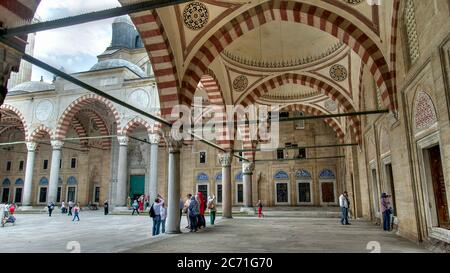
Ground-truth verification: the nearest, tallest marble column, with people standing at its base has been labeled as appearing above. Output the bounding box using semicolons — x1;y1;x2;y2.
166;137;183;234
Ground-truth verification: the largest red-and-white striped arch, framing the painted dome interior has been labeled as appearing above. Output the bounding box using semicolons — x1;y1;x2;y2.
183;1;395;110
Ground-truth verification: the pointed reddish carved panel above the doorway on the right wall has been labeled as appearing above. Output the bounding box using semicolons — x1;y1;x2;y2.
414;92;437;131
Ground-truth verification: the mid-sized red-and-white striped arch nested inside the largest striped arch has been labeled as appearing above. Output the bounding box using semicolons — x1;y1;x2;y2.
241;73;361;143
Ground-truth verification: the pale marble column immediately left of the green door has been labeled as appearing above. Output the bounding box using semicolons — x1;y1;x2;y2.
115;136;128;207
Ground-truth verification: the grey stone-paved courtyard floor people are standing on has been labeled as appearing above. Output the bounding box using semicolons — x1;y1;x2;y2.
0;212;427;253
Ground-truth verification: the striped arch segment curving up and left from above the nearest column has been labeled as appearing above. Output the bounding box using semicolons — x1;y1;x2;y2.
130;10;182;120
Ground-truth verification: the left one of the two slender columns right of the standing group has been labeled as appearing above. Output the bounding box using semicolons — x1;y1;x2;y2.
219;153;233;218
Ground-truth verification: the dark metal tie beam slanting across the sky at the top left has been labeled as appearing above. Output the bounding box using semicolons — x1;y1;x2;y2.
0;0;190;37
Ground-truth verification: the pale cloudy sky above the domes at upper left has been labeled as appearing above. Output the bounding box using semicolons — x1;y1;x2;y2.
32;0;120;82
